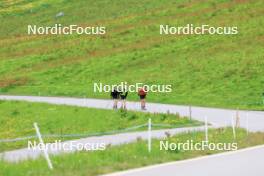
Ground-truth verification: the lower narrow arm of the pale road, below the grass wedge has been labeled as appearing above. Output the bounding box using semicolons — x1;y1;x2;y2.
0;127;204;162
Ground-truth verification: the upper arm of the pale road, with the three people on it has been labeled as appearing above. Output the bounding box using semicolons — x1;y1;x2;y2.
0;95;264;132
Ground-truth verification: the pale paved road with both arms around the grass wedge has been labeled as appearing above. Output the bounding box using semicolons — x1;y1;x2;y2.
0;95;264;162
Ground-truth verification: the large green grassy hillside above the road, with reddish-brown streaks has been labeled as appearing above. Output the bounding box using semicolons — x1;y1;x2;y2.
0;0;264;109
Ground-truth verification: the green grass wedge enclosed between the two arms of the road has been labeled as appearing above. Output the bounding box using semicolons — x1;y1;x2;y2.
0;101;203;152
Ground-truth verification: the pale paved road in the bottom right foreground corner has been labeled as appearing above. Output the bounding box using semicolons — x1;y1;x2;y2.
105;145;264;176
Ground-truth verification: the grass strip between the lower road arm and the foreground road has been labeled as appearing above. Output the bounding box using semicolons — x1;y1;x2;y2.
0;128;264;176
